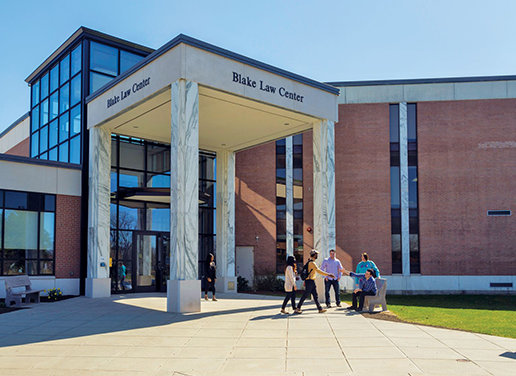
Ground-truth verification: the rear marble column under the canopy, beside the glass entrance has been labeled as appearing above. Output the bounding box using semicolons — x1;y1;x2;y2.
216;150;237;292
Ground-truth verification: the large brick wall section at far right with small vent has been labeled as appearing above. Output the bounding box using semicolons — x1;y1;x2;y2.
418;99;516;275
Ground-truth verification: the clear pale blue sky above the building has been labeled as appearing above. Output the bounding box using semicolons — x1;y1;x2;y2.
0;0;516;132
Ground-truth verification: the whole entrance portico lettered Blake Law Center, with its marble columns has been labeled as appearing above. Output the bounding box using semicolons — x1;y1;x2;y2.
86;35;339;312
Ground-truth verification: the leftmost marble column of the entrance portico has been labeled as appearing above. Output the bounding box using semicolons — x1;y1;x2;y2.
86;127;111;298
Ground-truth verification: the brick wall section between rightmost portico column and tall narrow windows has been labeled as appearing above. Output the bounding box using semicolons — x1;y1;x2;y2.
335;103;392;274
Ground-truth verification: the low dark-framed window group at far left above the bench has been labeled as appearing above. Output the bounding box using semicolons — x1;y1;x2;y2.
0;190;56;275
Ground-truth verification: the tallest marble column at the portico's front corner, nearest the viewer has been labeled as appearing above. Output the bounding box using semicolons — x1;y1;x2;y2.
167;79;201;313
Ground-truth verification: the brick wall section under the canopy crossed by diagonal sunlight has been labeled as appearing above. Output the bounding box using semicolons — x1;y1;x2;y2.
235;142;276;271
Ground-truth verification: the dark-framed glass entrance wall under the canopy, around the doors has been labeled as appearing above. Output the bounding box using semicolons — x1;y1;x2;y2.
110;136;216;291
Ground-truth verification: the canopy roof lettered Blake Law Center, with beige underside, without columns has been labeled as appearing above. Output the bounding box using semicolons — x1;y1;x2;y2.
87;35;339;151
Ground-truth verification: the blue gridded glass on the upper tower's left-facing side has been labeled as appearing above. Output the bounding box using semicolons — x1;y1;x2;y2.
30;44;83;164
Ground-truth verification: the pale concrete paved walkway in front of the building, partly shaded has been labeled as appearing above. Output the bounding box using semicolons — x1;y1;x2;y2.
0;294;516;376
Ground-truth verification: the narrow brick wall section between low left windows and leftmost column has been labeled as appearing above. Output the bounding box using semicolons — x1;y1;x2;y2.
56;195;81;278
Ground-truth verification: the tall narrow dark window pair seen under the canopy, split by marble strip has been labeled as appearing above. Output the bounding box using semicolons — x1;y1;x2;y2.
276;134;303;274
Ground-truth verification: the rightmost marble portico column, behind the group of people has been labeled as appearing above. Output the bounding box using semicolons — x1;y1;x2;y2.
313;120;335;301
